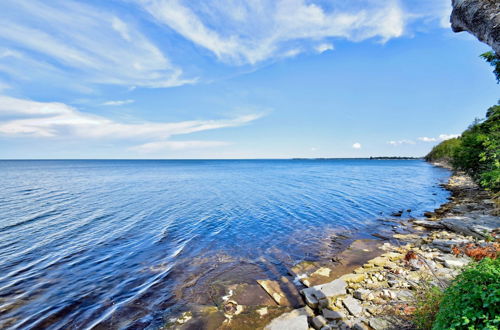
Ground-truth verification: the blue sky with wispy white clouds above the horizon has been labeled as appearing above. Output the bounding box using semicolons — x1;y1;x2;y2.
0;0;500;159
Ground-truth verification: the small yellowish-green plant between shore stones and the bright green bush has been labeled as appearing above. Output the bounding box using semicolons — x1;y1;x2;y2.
412;284;443;330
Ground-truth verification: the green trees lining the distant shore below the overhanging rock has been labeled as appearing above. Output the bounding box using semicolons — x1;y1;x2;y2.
425;102;500;192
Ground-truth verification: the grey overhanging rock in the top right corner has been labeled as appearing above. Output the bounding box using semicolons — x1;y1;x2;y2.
451;0;500;55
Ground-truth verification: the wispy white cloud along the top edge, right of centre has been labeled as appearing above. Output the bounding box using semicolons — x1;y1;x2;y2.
135;0;404;64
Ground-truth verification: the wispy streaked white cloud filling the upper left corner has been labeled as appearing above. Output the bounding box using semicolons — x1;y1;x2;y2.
0;0;195;87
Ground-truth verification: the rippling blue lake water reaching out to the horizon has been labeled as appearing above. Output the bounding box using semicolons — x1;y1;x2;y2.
0;160;449;329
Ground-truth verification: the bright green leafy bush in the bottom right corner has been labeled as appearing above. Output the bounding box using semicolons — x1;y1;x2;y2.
432;258;500;330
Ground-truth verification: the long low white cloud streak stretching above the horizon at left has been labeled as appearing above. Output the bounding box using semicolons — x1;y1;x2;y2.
0;96;261;148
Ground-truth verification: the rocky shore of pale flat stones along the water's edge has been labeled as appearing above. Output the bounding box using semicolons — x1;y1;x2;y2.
167;170;500;330
